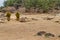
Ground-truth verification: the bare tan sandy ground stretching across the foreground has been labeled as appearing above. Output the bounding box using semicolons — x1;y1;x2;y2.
0;14;60;40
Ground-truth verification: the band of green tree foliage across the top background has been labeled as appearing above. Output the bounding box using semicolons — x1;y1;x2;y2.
4;0;60;11
